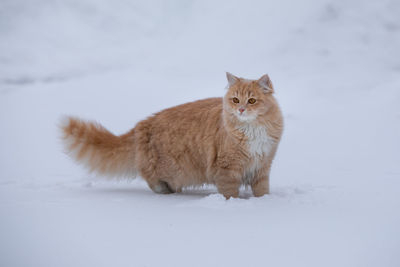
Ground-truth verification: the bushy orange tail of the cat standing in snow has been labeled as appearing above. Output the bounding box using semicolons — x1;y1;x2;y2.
60;117;136;177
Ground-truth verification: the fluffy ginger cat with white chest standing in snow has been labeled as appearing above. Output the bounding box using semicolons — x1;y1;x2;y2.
61;72;283;199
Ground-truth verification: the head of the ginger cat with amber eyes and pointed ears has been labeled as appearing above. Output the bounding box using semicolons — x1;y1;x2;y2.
224;72;276;122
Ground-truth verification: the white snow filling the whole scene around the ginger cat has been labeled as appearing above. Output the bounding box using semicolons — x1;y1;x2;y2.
0;0;400;267
